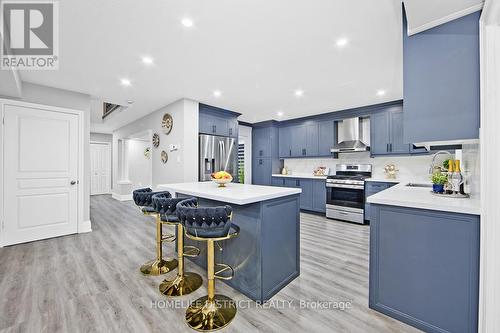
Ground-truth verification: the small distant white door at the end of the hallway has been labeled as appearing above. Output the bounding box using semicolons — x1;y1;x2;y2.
90;143;111;195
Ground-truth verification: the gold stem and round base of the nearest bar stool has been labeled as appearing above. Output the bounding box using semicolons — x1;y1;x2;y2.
186;240;236;332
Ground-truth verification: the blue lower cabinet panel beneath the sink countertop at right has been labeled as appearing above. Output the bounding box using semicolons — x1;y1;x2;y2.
369;204;480;333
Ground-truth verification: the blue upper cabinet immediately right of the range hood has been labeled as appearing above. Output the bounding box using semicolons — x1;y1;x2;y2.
370;106;410;156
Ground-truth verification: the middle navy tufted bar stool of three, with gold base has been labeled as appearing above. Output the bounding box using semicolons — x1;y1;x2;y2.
153;193;203;296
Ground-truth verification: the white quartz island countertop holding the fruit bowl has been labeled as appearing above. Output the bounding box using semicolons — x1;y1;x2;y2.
157;182;302;205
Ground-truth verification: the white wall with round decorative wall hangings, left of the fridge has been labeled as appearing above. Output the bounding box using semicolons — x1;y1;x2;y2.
113;99;198;196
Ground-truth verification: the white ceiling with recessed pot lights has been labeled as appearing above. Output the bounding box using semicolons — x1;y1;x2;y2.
21;0;402;132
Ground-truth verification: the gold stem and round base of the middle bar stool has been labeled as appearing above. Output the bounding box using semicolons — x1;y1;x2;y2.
159;223;203;296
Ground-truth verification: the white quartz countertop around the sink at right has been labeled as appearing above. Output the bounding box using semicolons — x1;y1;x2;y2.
367;181;481;215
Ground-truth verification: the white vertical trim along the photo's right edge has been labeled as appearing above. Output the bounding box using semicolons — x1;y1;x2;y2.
478;0;500;333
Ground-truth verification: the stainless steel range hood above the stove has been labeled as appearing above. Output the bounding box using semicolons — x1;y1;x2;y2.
330;117;370;153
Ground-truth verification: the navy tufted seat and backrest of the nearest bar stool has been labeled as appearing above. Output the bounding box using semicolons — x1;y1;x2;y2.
177;198;233;238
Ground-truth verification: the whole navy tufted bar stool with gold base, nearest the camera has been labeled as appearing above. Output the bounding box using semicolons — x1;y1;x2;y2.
177;198;240;332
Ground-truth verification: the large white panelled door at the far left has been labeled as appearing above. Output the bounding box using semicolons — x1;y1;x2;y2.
2;104;79;245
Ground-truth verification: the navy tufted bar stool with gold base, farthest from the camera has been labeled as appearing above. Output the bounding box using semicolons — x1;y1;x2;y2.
132;188;177;276
